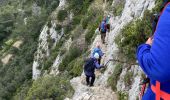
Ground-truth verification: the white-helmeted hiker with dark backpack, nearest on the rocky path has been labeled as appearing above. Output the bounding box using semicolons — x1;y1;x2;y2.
84;53;104;86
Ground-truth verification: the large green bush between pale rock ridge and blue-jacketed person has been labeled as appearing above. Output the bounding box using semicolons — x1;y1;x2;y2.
115;0;162;61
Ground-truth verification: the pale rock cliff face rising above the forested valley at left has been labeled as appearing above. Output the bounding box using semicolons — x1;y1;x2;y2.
32;0;65;79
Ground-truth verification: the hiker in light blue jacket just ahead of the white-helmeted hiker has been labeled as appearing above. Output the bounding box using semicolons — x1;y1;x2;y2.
91;43;104;64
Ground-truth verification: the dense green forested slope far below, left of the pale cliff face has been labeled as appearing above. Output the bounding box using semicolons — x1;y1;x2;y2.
0;0;58;100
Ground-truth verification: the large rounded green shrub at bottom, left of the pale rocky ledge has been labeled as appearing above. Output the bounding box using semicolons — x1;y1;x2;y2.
26;76;74;100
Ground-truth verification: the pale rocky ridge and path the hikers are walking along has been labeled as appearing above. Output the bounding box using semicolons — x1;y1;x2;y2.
67;0;155;100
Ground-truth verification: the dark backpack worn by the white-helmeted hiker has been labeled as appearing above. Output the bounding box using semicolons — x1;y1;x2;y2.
84;58;95;72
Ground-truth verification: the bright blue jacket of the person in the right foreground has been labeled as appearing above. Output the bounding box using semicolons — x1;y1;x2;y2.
137;4;170;100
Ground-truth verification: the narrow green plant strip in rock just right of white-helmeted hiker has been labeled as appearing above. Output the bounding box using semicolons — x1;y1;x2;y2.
108;64;122;91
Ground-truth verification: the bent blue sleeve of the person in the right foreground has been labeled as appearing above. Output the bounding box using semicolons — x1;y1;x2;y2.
137;44;164;81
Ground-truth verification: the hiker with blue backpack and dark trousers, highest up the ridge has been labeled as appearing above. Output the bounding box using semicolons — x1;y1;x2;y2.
99;18;107;44
